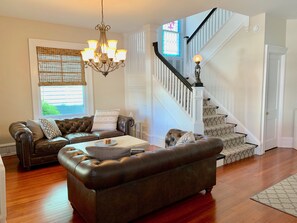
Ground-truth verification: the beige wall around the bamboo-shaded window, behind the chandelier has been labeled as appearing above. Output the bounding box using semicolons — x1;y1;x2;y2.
0;17;125;145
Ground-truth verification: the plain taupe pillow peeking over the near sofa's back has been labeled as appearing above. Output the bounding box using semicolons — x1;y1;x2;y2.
86;146;131;160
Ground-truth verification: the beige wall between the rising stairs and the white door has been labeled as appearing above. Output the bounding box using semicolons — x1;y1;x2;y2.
201;14;265;140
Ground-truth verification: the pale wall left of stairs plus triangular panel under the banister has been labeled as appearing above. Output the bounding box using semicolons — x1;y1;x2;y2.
125;25;193;146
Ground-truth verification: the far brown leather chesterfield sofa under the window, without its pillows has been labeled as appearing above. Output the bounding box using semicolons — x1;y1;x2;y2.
9;115;134;169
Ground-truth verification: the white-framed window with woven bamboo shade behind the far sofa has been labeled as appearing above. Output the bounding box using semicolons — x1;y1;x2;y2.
29;40;93;119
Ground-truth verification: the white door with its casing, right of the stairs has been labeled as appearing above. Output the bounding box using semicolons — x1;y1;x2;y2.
261;45;287;152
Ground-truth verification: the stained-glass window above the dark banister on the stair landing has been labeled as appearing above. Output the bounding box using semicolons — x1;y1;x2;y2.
162;20;180;56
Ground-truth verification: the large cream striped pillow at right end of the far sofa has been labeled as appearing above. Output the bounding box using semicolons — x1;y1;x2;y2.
92;109;120;132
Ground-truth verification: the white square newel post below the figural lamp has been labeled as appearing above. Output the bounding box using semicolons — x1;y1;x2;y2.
192;87;204;134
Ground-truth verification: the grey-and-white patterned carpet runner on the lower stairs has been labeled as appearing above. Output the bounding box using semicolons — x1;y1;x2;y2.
203;99;257;164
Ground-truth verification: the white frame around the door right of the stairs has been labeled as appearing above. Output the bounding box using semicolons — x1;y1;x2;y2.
260;44;287;154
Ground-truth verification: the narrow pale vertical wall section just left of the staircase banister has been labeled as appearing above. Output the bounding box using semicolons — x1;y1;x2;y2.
125;25;159;141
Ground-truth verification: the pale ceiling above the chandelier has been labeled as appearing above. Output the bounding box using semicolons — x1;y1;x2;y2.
0;0;297;32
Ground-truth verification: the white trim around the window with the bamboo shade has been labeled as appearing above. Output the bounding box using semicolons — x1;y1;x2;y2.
29;39;94;119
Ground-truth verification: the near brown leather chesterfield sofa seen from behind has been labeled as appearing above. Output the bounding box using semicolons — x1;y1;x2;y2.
58;132;223;223
